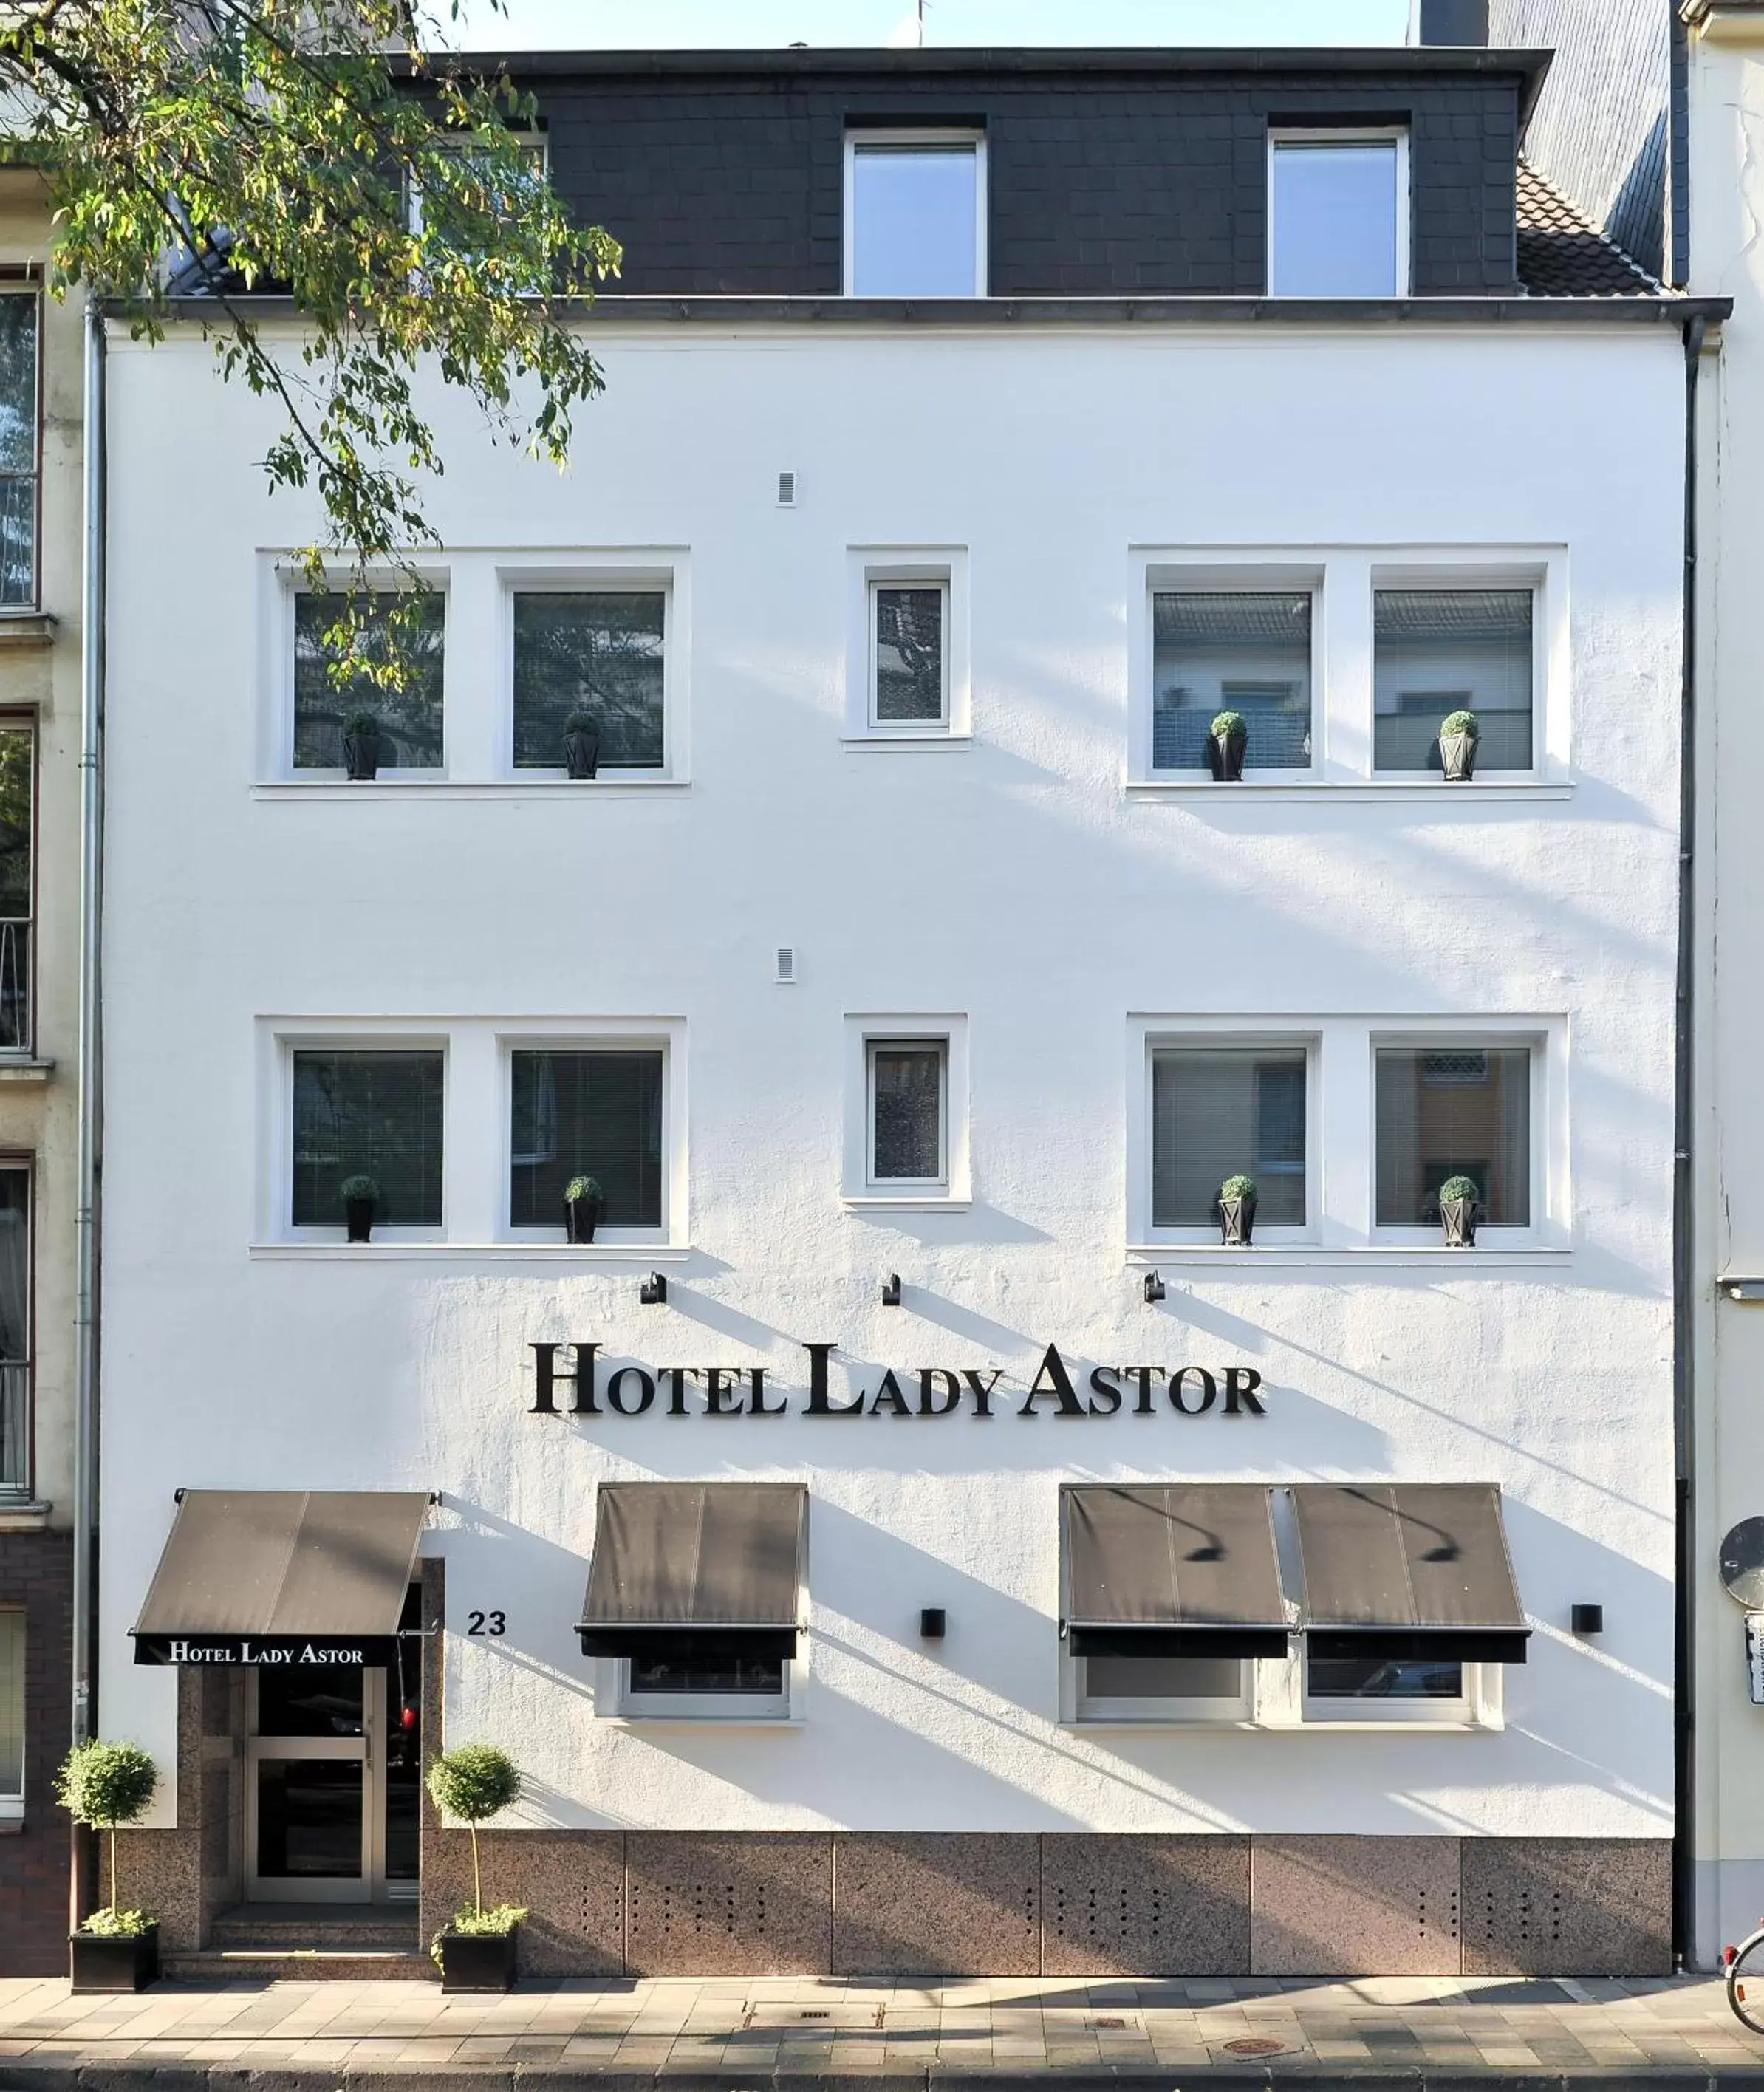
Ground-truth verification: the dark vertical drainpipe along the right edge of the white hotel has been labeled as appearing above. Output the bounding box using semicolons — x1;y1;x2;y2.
1672;312;1708;1969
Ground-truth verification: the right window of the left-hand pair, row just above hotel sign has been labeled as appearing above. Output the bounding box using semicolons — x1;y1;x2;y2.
508;1050;663;1228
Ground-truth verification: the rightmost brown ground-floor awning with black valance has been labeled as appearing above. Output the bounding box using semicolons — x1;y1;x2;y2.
1293;1481;1530;1663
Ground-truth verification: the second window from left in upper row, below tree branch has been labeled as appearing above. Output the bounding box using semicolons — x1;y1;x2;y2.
515;588;668;770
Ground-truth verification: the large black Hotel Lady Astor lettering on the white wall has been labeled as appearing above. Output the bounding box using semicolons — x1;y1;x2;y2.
527;1343;1268;1421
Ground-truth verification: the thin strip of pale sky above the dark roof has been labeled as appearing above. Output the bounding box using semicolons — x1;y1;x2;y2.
458;0;1408;50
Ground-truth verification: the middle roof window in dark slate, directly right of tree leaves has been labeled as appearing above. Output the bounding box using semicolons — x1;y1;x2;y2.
845;131;985;297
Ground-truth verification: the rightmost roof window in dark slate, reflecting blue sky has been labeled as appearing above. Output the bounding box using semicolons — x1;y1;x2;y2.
1268;131;1408;297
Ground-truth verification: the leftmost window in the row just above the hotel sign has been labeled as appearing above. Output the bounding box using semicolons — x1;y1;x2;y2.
293;1048;444;1228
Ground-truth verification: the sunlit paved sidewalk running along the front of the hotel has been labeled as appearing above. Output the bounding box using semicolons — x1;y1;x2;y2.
0;1977;1764;2092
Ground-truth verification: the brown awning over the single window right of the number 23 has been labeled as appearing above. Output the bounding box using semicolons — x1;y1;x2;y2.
575;1481;807;1657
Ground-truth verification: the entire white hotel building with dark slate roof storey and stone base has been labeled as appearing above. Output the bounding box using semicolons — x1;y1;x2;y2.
100;52;1684;1973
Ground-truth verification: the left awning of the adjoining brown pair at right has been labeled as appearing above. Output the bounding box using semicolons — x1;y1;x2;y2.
1061;1481;1287;1657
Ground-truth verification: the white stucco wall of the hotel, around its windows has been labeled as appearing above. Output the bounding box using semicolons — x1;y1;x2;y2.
103;324;1683;1836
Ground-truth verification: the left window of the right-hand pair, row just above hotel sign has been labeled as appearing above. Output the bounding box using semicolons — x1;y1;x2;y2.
1151;1046;1306;1228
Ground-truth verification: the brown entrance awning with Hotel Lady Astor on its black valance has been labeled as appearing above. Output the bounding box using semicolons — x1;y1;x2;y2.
130;1489;429;1665
